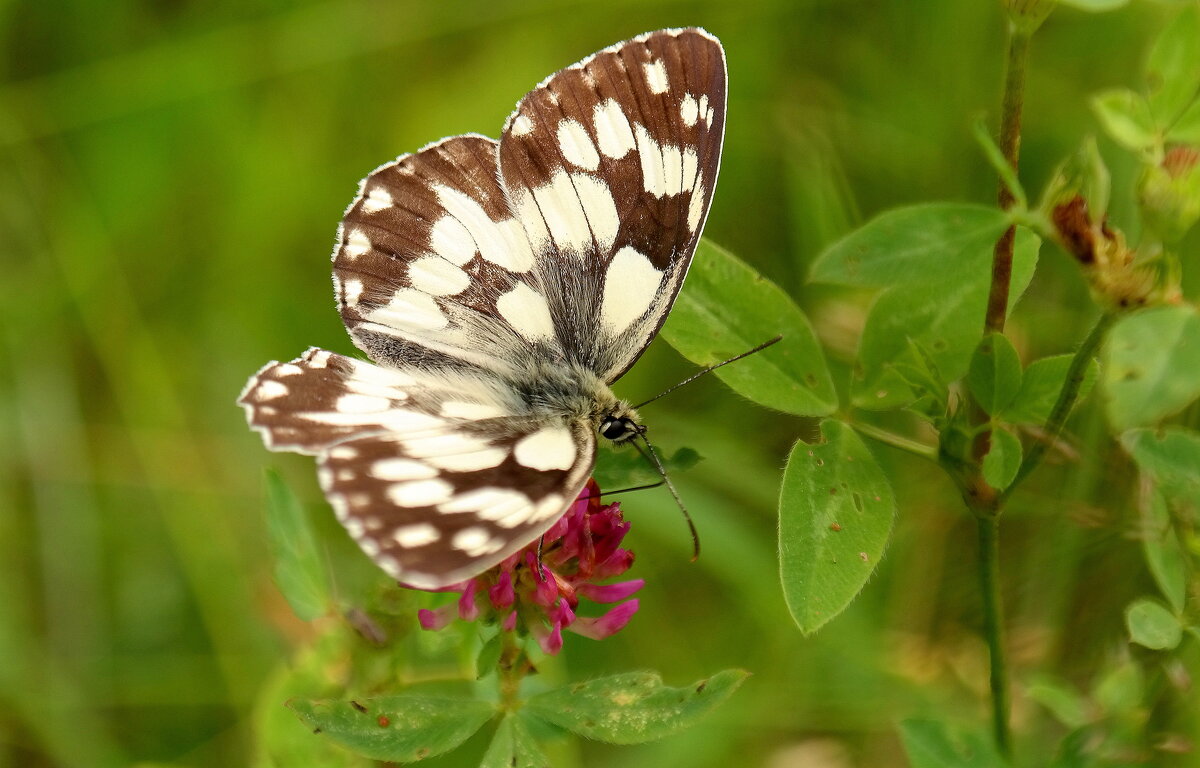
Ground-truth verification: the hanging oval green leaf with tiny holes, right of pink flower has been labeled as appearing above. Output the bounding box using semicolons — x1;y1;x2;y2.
779;420;895;634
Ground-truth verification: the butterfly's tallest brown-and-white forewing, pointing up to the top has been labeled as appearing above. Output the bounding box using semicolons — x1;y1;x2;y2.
499;29;726;382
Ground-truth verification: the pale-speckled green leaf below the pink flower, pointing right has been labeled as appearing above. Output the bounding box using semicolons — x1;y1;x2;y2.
523;670;750;744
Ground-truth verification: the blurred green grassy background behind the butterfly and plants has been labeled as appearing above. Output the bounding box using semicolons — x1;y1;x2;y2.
0;0;1195;768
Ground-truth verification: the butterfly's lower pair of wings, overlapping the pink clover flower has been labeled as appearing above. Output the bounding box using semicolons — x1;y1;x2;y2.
239;349;595;589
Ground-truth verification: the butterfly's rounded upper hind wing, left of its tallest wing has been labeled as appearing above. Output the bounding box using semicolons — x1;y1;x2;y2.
334;136;560;372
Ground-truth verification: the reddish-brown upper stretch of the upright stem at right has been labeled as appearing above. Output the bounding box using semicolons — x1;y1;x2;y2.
986;29;1031;332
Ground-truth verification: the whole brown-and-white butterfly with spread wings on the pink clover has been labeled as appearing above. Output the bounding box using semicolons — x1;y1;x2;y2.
238;28;726;589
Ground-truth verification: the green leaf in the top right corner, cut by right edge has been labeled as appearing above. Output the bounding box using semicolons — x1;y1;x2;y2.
1146;2;1200;128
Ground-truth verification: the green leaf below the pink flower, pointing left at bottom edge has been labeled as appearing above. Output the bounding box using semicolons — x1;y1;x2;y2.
288;694;496;763
